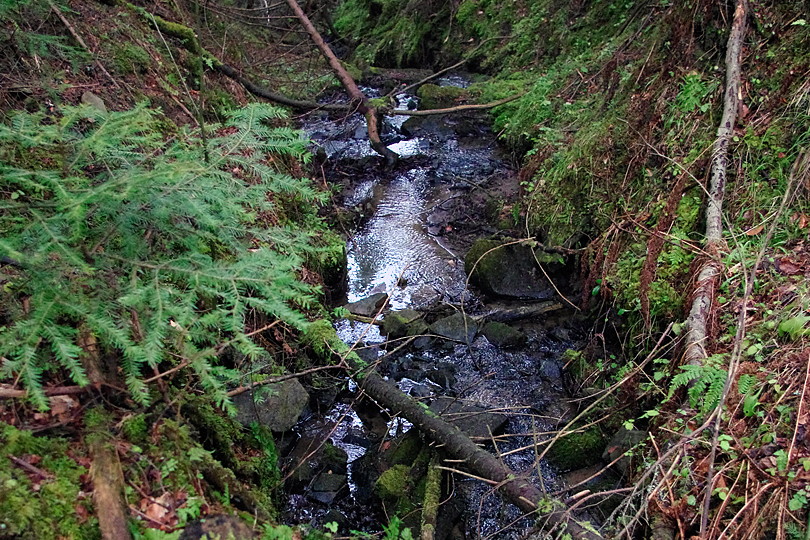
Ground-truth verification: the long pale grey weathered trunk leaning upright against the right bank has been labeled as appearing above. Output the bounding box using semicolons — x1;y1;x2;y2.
684;0;748;365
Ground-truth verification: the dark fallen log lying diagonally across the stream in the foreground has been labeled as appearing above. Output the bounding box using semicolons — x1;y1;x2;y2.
357;364;602;540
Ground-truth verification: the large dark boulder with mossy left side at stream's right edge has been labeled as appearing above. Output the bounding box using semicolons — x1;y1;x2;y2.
464;239;554;300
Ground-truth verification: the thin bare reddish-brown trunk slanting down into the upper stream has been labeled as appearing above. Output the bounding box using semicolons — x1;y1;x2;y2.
287;0;399;164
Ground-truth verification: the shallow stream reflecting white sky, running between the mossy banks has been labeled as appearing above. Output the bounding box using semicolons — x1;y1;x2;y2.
285;75;582;538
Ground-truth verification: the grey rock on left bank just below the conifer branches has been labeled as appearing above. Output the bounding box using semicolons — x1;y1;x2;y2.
233;379;309;431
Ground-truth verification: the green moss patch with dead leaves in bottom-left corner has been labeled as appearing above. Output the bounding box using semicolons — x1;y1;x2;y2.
0;423;100;540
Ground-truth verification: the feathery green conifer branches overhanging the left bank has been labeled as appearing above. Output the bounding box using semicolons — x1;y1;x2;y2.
0;104;324;408
